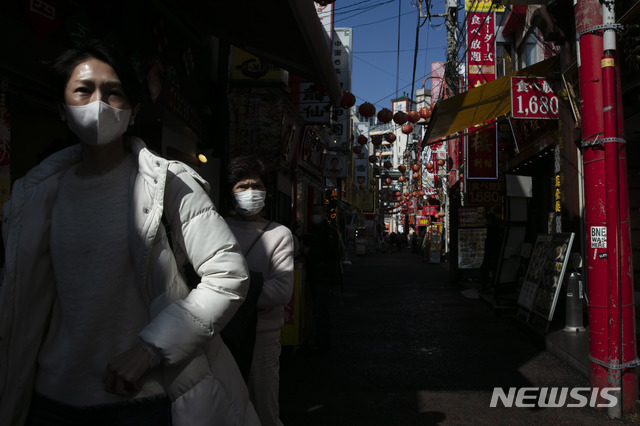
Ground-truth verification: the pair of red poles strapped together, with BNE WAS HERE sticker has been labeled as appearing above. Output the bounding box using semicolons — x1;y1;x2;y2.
575;0;638;418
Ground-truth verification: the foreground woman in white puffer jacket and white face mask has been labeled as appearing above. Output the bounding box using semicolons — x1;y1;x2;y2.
0;40;259;425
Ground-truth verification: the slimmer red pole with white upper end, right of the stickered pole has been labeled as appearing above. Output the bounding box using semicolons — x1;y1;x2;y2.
601;2;638;418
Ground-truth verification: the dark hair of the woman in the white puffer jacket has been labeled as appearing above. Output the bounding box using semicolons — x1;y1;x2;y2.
51;40;142;107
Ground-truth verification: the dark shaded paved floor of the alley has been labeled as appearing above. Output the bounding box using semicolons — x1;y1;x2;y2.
280;249;640;426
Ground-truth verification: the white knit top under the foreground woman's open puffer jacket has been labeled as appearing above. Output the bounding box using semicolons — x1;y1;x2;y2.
36;155;164;406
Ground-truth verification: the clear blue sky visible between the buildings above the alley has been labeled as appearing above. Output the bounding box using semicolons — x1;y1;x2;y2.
334;0;446;111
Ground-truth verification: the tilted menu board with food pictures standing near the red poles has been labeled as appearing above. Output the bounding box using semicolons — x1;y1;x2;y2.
518;233;574;321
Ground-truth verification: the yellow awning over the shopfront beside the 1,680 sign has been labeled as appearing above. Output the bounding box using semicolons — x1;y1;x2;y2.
423;56;559;144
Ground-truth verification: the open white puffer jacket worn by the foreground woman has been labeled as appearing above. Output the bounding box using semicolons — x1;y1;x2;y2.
0;138;259;425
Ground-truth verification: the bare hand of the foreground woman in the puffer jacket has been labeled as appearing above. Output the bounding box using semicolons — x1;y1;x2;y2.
102;342;151;396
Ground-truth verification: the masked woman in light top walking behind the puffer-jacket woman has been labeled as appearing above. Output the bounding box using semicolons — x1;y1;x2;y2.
227;156;294;426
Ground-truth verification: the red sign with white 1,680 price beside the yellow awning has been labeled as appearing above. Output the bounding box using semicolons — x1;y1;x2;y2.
511;77;559;119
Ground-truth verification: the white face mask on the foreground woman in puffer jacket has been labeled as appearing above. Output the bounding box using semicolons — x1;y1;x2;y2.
64;101;131;145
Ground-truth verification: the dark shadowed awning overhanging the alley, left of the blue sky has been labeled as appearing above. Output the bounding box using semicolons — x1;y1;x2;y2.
177;0;342;105
